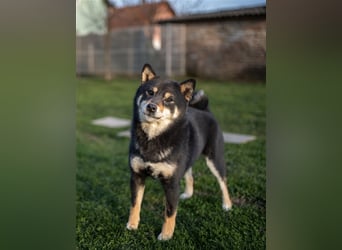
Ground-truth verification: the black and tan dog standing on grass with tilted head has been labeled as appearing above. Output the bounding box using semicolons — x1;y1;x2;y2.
127;64;232;240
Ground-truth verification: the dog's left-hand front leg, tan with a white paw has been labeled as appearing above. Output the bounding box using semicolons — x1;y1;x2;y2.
126;171;145;230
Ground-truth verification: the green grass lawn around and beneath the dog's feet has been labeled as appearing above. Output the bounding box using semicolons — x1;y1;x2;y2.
76;78;266;249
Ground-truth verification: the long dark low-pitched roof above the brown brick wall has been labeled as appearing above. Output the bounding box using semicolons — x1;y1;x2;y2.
158;6;266;24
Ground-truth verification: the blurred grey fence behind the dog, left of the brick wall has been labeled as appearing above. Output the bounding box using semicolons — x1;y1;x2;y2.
76;24;186;76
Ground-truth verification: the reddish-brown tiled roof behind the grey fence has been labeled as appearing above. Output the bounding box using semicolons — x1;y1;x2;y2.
109;2;175;30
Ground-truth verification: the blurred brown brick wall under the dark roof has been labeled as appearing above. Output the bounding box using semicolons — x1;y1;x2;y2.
186;17;266;81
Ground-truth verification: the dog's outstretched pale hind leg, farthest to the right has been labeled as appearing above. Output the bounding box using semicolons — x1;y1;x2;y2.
205;157;232;211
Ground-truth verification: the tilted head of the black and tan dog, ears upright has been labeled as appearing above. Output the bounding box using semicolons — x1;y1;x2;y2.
135;64;196;135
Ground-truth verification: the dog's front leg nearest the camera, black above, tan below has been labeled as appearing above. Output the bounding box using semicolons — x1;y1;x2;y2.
158;180;179;240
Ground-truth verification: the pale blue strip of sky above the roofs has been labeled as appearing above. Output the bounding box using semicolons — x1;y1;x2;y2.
110;0;266;15
